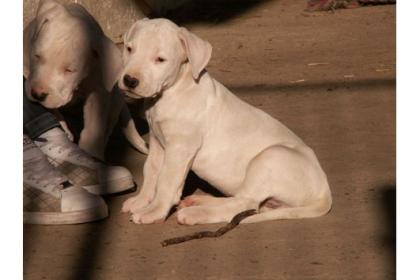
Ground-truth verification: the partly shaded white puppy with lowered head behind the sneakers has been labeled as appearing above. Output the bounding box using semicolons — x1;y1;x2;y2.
24;0;147;158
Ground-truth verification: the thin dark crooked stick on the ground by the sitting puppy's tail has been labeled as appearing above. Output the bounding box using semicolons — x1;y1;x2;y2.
160;209;257;247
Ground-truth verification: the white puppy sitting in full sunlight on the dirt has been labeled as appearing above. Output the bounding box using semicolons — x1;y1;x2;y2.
119;19;332;225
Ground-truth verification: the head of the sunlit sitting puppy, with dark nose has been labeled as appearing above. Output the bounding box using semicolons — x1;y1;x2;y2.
118;19;212;98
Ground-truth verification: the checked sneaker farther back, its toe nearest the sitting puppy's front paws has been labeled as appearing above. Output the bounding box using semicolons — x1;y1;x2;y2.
34;128;135;195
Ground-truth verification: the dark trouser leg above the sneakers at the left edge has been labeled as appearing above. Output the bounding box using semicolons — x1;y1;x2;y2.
23;79;60;139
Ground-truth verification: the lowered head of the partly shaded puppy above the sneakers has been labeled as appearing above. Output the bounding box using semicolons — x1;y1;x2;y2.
25;0;94;108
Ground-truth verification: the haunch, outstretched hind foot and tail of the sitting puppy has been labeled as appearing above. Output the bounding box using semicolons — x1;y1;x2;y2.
178;145;332;225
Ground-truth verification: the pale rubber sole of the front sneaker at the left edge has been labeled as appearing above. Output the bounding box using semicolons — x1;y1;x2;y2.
23;204;108;225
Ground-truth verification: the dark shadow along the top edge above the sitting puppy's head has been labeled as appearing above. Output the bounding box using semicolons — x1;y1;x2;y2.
135;0;272;24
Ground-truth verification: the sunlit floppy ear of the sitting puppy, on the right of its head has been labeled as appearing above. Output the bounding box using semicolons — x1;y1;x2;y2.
178;27;212;79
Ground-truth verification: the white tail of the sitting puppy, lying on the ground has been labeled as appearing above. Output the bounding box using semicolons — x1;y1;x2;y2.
241;192;332;223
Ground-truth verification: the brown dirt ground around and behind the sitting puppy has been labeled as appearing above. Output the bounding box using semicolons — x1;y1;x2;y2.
24;0;396;280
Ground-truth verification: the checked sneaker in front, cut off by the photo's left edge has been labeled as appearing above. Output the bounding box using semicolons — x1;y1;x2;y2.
23;136;108;225
